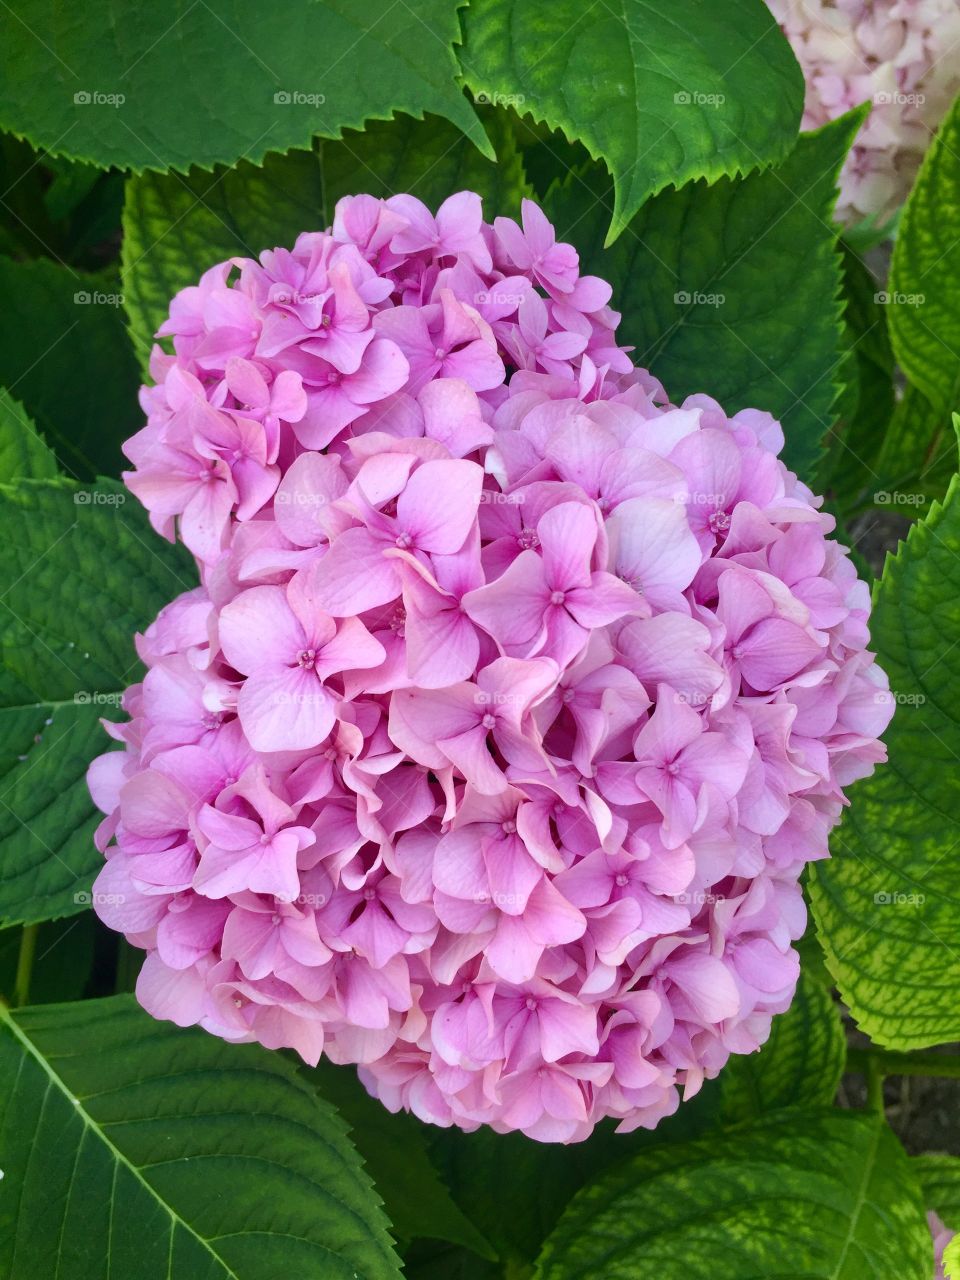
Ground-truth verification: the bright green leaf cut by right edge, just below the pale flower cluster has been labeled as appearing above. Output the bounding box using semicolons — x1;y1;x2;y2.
888;99;960;413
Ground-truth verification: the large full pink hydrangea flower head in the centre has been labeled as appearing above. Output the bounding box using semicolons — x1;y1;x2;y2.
90;192;892;1142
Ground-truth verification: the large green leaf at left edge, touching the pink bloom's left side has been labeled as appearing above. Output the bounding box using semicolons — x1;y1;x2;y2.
0;480;195;924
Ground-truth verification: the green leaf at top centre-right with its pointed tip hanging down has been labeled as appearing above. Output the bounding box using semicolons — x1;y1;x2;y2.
460;0;804;241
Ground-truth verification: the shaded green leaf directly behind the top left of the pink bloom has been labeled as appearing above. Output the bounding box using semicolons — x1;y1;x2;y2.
123;116;527;364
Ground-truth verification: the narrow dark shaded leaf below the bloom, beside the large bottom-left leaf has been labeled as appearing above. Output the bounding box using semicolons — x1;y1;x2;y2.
312;1060;497;1261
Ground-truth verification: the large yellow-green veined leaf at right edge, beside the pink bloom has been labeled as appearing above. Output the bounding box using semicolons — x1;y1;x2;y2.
810;424;960;1050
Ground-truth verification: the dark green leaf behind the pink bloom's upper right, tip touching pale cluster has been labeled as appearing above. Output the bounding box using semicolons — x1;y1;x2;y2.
549;112;863;481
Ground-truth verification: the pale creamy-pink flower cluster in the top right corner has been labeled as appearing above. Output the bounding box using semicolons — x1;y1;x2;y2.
768;0;960;224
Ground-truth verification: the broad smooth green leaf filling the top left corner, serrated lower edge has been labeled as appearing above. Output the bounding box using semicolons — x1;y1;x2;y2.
0;0;486;173
